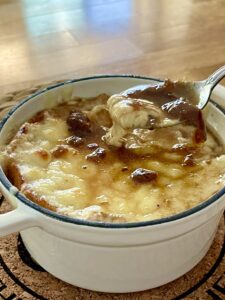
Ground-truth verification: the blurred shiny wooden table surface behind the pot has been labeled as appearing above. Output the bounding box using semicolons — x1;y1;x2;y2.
0;0;225;95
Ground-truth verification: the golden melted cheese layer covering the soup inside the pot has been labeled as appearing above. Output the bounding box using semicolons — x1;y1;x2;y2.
1;95;225;222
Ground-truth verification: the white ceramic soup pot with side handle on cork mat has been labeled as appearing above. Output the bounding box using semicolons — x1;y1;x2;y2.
0;75;225;293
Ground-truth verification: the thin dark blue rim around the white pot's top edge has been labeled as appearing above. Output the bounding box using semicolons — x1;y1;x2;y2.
0;74;225;229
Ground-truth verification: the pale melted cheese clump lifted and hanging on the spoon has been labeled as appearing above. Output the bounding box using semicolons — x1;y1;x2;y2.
103;94;181;149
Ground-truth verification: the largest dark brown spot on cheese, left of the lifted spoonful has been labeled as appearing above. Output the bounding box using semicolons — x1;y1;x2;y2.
66;111;91;137
